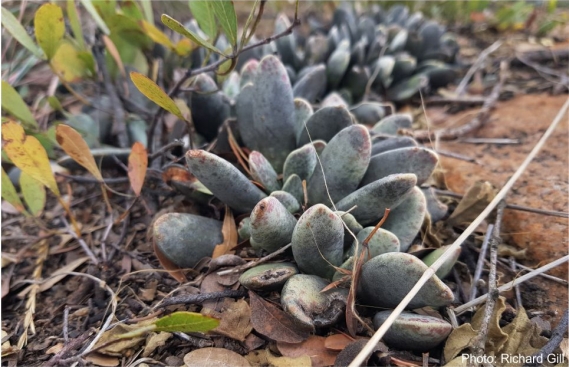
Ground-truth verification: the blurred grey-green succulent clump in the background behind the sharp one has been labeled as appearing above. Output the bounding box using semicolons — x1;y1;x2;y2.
262;3;458;103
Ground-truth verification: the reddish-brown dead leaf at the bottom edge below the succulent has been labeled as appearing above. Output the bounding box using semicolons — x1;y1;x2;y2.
277;335;338;367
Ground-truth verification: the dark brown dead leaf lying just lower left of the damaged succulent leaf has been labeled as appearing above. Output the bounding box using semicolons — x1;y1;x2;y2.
249;291;310;344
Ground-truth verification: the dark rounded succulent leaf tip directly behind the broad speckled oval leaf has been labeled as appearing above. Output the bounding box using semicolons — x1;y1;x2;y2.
297;106;354;146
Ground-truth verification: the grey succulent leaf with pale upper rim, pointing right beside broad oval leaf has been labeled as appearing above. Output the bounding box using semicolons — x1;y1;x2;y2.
361;147;439;185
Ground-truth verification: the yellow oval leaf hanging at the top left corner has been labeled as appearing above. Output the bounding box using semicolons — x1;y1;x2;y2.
34;3;65;60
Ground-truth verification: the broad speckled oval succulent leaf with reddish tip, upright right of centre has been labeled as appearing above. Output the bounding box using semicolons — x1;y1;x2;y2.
308;125;371;205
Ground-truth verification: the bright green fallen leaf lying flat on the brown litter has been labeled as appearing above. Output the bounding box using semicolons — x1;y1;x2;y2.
154;311;219;333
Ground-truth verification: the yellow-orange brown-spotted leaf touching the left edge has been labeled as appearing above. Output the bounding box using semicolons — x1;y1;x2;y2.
2;121;61;197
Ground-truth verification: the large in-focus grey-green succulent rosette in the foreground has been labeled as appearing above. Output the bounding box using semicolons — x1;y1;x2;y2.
154;56;453;350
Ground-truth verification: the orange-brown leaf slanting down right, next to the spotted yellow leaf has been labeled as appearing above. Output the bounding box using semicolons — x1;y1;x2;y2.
55;124;103;182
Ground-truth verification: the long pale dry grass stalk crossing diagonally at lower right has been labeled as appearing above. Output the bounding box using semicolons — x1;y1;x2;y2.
349;90;569;367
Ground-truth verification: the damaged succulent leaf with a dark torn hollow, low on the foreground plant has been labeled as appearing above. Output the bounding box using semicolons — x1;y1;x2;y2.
281;274;348;327
